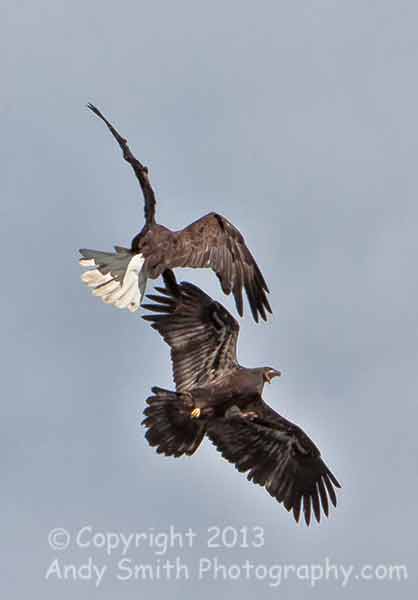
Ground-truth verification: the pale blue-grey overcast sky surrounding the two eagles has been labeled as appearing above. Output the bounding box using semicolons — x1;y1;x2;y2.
0;0;418;600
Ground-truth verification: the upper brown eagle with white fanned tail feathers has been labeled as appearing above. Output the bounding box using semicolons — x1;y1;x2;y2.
80;104;271;321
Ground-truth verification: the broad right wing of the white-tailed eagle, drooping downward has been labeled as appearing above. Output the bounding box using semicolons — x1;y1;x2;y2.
141;213;271;322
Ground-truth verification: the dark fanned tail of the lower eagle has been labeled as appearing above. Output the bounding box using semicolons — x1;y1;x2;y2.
142;387;205;457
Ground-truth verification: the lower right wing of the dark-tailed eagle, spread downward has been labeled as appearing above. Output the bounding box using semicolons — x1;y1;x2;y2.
207;399;341;525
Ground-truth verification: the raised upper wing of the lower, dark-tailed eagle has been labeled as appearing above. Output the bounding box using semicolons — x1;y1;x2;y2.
143;274;239;392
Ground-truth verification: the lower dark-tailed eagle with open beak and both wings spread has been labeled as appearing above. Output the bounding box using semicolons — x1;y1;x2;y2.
143;277;340;525
